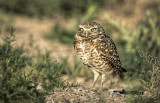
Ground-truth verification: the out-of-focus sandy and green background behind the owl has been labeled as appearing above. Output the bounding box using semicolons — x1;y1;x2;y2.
0;0;160;100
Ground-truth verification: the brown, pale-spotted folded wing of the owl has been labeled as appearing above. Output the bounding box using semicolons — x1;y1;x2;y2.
100;36;122;68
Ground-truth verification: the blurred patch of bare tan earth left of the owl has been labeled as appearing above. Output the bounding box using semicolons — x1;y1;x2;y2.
13;17;73;60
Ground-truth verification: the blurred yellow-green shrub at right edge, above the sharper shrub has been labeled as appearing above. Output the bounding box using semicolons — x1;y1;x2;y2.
134;9;160;56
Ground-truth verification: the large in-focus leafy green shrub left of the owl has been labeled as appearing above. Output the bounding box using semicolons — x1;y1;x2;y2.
0;28;64;103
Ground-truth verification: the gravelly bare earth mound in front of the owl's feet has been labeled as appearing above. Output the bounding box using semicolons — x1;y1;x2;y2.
46;86;126;103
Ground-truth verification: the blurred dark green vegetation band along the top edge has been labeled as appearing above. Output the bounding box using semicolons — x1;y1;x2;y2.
0;0;120;16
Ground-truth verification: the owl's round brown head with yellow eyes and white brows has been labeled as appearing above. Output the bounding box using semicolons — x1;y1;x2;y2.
77;22;105;39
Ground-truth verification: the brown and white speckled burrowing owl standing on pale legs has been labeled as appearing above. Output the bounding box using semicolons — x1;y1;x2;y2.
74;22;126;88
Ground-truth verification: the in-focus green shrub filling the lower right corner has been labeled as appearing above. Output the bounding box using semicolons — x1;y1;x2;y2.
127;52;160;103
